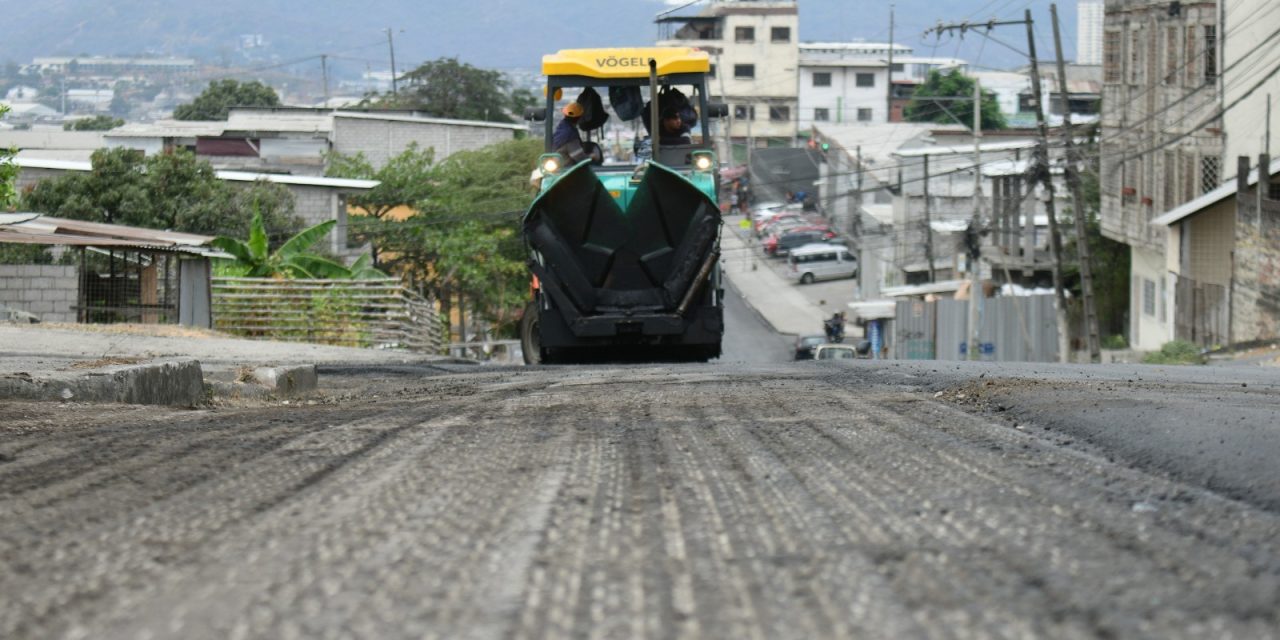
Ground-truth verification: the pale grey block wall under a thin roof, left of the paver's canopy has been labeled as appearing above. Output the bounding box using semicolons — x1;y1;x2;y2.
333;116;516;166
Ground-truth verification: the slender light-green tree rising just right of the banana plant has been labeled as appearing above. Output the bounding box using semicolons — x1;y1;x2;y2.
325;143;435;266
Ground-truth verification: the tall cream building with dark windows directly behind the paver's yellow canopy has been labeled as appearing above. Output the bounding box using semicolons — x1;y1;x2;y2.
657;0;800;146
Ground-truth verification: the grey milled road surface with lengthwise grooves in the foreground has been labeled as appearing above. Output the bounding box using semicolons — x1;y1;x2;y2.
0;365;1280;639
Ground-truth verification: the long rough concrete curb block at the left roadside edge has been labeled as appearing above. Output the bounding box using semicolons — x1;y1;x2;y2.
0;358;205;407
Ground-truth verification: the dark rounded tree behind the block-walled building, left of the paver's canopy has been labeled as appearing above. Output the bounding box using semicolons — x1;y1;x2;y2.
371;58;512;122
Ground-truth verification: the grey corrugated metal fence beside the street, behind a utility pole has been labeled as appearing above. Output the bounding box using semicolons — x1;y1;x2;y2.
893;296;1057;362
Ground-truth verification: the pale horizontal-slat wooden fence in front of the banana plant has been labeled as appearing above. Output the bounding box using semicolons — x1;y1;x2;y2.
212;278;447;353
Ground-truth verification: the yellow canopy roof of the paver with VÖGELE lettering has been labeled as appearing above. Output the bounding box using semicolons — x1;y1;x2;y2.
543;47;710;78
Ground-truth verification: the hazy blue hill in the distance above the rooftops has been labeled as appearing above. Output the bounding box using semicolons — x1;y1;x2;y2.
0;0;1075;68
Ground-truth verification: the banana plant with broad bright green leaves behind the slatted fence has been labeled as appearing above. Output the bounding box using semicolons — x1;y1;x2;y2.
212;214;385;279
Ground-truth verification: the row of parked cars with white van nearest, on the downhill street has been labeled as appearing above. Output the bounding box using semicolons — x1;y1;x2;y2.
751;202;858;284
